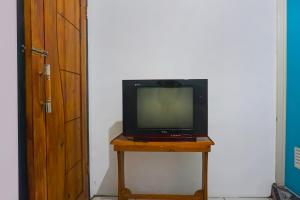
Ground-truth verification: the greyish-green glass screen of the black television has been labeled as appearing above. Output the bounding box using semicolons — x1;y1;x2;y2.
137;87;194;128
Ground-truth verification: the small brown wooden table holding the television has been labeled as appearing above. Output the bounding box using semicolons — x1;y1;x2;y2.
111;135;214;200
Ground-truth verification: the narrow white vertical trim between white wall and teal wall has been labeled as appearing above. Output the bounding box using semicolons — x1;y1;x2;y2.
275;0;287;186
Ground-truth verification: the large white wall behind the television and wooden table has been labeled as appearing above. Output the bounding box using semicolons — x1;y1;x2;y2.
88;0;276;197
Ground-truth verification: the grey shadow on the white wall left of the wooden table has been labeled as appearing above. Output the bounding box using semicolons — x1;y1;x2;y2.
97;121;123;195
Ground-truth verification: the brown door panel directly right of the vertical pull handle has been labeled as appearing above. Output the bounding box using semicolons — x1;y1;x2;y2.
61;71;81;122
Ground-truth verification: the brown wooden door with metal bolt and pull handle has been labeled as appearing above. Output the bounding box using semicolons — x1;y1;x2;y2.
24;0;88;200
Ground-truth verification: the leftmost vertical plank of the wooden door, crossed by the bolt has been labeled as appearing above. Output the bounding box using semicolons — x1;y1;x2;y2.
25;0;47;200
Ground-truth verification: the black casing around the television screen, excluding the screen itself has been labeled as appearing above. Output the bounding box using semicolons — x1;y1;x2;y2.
123;79;208;140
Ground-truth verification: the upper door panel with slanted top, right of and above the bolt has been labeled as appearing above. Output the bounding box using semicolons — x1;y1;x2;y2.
57;14;81;74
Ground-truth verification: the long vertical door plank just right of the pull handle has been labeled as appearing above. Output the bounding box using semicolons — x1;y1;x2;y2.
44;0;66;200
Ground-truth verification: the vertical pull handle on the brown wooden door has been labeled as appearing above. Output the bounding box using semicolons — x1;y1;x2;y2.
41;64;52;113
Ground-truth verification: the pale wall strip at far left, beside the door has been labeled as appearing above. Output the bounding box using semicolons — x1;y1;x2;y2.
0;0;18;200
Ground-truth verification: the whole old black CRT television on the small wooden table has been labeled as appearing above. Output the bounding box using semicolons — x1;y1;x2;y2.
123;79;207;140
